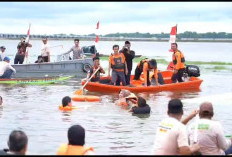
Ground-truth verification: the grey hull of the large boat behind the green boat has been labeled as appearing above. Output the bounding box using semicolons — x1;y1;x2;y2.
12;58;93;78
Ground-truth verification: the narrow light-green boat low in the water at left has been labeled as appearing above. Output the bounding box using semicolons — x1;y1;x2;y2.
0;76;72;85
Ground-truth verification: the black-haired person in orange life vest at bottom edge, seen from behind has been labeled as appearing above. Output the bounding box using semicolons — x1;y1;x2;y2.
57;125;95;155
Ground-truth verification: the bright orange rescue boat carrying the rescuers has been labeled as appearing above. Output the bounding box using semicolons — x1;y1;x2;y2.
82;71;203;93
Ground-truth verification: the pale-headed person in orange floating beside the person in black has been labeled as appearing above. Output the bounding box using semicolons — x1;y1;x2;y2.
115;89;137;109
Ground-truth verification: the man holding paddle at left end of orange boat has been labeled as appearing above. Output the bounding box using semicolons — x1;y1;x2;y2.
87;57;105;82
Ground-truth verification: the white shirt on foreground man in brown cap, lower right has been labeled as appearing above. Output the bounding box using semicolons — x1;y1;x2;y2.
188;119;231;155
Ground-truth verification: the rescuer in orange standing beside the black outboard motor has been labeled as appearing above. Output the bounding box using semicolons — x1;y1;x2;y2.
171;43;185;83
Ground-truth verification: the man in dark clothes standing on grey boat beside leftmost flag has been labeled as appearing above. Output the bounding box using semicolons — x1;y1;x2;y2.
14;37;32;64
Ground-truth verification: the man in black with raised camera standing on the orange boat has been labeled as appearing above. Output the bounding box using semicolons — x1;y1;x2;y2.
119;41;135;85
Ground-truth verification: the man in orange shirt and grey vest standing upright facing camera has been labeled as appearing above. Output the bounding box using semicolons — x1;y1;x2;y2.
108;45;128;86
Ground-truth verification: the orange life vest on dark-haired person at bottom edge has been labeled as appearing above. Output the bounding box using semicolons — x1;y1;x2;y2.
57;144;93;155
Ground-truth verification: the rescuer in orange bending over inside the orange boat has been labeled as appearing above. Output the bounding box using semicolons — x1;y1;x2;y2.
134;58;163;87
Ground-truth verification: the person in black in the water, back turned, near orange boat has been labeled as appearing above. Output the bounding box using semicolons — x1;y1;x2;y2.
129;96;151;114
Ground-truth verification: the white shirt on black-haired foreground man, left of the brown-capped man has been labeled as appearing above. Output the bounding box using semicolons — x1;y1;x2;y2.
152;117;189;155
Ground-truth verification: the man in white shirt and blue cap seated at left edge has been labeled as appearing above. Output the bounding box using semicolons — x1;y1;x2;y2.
0;57;16;79
